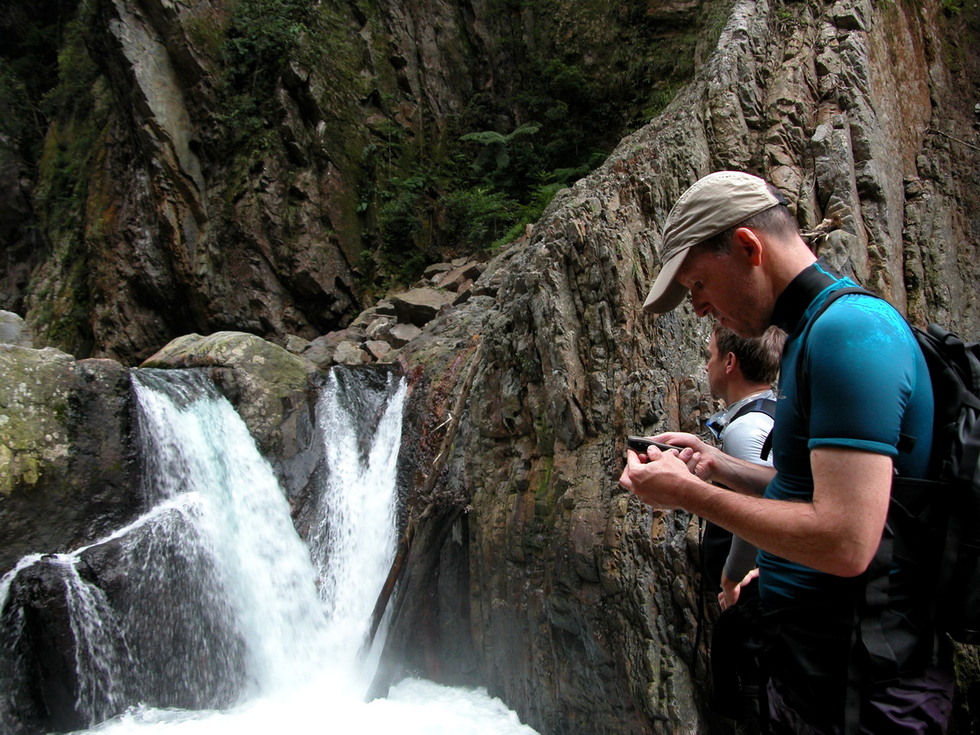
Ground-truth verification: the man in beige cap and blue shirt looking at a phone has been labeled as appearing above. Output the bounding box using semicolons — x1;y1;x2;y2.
620;171;952;734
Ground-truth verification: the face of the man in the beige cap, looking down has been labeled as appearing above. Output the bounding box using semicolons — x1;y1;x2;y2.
676;247;769;337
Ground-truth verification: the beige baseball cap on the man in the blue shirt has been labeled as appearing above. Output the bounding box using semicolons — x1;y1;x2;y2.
643;171;786;314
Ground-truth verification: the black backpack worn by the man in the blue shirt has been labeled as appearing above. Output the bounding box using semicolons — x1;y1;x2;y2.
810;287;980;644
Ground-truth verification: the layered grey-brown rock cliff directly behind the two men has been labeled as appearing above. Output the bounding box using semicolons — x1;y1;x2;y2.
0;0;980;735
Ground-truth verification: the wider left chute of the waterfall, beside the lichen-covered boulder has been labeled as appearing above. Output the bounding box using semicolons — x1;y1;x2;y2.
135;371;326;693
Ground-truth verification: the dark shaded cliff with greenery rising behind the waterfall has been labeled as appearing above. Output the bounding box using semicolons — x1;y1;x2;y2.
0;0;715;364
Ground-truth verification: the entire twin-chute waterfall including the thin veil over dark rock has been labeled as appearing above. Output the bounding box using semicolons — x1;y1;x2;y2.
0;368;534;735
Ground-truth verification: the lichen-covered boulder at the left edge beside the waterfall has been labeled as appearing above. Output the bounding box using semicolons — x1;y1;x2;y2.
0;344;140;574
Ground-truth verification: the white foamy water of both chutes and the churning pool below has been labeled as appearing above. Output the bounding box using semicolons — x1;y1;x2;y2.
0;371;535;735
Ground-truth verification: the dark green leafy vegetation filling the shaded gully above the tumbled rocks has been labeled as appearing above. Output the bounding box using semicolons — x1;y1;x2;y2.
359;0;727;281
